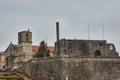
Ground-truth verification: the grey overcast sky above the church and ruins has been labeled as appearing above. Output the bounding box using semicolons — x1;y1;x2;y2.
0;0;120;52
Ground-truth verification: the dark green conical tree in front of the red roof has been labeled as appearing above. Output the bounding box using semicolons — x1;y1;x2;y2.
35;41;50;58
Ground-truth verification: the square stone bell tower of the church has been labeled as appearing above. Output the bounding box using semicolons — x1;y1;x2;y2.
18;29;33;61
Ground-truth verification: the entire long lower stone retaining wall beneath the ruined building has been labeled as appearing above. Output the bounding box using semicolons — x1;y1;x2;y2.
22;58;120;80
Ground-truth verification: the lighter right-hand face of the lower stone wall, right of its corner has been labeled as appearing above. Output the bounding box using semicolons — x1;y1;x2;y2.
63;58;120;80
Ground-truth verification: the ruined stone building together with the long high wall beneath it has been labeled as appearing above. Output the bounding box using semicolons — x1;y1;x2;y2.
19;39;120;80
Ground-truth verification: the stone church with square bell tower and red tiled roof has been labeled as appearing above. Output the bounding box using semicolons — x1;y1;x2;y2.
5;29;54;68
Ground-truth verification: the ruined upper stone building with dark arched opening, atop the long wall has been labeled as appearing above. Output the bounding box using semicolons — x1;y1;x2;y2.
55;39;118;57
